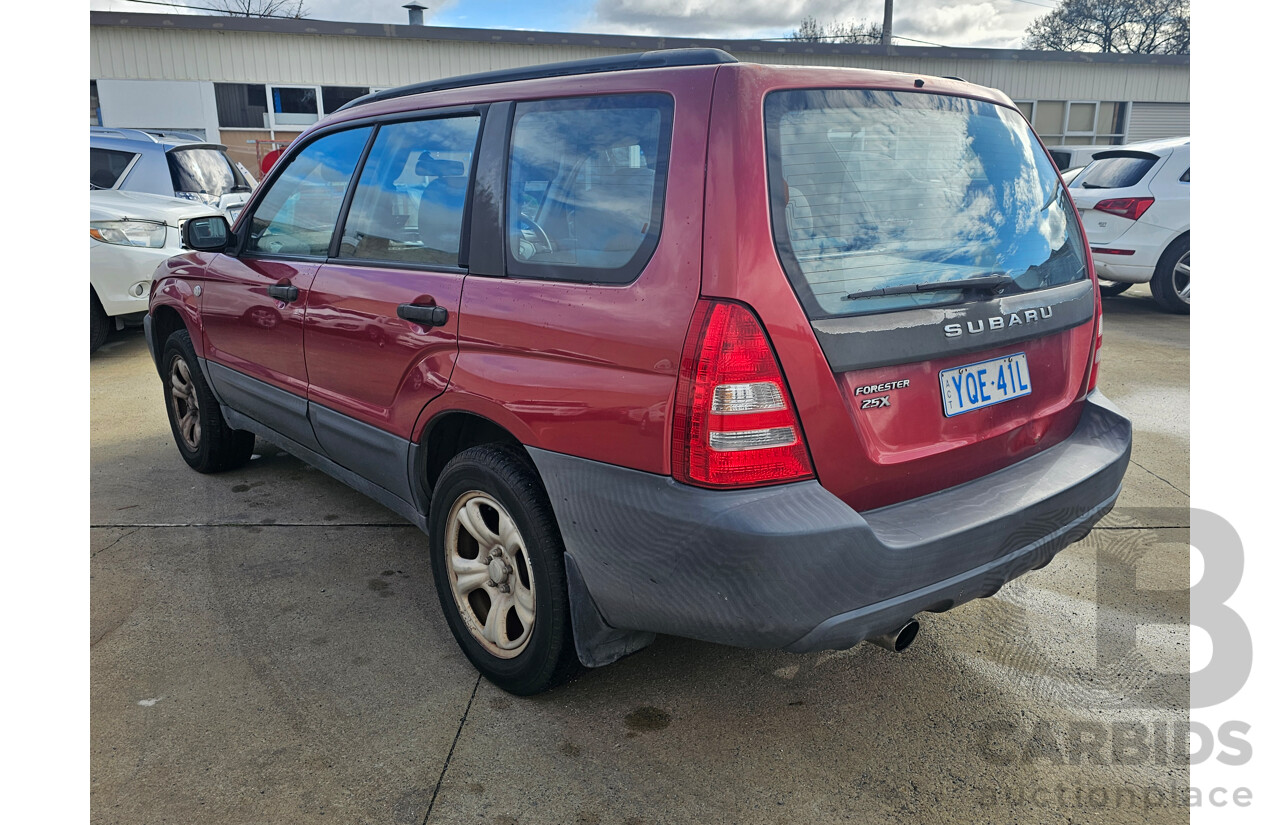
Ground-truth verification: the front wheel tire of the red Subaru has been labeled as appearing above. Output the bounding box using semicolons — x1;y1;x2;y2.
160;330;253;473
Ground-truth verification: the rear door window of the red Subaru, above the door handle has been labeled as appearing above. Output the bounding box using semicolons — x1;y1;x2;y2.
338;115;480;266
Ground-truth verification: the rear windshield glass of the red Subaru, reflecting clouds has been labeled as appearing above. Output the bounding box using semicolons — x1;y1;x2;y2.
764;90;1087;318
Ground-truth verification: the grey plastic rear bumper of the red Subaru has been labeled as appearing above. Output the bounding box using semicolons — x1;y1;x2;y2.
529;393;1132;665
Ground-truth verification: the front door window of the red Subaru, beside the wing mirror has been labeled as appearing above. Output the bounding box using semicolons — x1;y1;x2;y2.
244;127;371;257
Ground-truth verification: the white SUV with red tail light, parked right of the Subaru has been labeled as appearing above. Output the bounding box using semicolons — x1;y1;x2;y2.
1069;138;1192;313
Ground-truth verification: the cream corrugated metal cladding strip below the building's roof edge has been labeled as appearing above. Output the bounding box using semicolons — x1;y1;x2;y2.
90;26;1190;104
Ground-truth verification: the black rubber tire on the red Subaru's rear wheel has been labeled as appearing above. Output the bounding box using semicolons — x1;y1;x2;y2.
429;444;580;696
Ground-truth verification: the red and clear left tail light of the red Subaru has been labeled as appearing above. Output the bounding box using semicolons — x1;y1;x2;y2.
671;299;813;487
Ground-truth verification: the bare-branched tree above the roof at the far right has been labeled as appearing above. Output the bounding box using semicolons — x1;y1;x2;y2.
1023;0;1192;55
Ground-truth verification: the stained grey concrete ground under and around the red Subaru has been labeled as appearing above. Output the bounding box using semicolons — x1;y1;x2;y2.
90;288;1190;825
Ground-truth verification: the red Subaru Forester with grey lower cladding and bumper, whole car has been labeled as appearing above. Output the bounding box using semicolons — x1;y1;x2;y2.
146;50;1132;693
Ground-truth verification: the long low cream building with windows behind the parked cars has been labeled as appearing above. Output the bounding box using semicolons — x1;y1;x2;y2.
90;12;1190;175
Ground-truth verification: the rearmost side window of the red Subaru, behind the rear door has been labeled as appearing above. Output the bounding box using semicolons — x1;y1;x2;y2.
507;95;673;284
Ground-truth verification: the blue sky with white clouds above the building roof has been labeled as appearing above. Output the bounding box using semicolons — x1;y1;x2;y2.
90;0;1060;49
